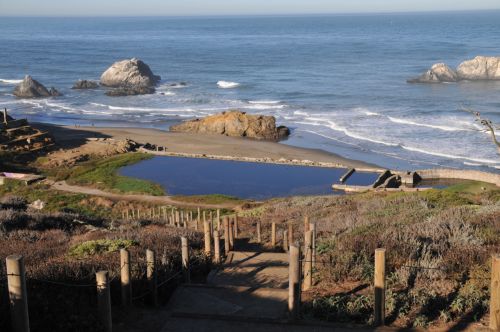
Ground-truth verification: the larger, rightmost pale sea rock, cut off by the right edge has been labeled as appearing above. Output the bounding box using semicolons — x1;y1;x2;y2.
457;56;500;81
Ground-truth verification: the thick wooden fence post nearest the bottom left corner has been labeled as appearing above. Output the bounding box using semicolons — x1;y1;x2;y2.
6;255;30;332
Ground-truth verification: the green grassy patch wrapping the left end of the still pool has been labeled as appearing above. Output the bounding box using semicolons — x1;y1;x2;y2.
48;153;165;196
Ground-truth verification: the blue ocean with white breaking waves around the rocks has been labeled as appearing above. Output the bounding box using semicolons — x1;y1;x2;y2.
0;11;500;172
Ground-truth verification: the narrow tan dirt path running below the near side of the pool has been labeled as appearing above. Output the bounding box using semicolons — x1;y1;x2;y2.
52;181;239;209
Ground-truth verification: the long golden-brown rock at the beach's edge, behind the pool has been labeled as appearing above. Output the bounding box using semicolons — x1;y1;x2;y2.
170;111;290;141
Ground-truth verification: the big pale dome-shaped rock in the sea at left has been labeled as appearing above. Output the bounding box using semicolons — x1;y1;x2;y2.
101;58;161;88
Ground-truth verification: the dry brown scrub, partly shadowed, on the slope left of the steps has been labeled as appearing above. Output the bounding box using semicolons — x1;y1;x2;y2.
0;198;210;331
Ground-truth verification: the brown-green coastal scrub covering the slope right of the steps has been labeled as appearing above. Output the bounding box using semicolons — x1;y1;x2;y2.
235;181;500;329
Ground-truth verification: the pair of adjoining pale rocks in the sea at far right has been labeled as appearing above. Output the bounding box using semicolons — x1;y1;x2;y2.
408;56;500;83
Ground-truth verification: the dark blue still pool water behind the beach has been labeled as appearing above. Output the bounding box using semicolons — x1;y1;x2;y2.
120;157;377;199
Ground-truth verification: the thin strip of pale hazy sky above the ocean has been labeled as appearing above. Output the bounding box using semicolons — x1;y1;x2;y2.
0;0;500;16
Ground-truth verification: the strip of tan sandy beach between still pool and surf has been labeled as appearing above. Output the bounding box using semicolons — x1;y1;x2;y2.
36;123;378;168
